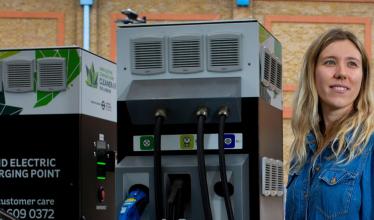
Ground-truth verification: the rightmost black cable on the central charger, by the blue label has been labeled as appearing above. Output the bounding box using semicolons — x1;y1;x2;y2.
218;106;234;220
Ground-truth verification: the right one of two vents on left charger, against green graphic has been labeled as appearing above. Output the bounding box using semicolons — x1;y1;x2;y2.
37;57;66;91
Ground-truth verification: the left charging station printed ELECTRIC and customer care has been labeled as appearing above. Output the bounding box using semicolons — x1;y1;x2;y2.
0;46;117;220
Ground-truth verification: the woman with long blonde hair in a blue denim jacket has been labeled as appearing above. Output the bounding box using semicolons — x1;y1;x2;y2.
286;29;374;220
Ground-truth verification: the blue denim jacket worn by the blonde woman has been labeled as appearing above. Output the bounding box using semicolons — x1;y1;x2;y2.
286;131;374;220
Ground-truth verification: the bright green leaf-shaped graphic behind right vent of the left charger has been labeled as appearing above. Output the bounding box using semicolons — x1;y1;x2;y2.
34;48;81;108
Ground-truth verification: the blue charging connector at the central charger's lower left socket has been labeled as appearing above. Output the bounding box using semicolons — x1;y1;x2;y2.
118;184;149;220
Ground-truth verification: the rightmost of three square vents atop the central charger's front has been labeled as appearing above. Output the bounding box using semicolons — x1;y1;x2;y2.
207;34;241;72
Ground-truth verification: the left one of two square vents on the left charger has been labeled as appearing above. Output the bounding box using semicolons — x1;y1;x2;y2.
3;60;34;92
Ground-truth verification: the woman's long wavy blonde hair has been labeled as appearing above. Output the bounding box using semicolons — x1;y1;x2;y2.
290;29;374;169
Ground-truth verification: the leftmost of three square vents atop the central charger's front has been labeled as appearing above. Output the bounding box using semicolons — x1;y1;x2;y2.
130;38;165;74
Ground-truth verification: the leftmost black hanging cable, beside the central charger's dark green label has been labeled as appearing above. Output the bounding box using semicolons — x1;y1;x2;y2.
153;109;166;220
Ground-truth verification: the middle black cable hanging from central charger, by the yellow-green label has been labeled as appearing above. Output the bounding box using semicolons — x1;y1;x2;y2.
196;107;213;220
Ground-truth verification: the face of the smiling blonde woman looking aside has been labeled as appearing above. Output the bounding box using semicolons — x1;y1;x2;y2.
315;40;363;113
